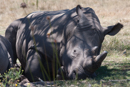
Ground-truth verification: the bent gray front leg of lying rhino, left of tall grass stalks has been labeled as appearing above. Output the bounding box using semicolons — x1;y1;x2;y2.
24;50;46;82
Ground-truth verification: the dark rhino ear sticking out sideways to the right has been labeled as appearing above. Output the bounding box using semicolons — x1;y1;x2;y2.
103;23;123;36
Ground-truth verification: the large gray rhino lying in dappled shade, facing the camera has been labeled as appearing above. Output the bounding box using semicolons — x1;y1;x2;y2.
5;5;123;81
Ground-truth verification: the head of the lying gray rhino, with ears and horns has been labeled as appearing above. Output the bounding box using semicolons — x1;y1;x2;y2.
61;5;123;79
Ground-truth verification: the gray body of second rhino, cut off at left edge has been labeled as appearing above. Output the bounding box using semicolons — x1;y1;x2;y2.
0;35;13;74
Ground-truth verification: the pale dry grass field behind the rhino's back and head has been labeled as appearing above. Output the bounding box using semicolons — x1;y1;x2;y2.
0;0;130;61
